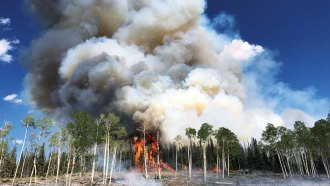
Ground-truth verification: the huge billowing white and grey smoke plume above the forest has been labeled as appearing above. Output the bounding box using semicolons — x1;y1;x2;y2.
24;0;328;142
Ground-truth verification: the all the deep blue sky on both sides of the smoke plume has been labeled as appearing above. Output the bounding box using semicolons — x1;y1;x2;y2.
0;0;330;142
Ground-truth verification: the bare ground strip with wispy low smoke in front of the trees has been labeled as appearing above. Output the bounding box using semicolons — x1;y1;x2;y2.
0;171;330;186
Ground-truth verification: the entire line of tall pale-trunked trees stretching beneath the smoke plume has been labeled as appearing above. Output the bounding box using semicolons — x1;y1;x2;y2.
0;112;330;185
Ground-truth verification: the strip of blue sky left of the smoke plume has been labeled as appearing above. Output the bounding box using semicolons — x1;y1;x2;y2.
0;0;38;142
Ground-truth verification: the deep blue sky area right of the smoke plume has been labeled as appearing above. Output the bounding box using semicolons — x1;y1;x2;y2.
207;0;330;97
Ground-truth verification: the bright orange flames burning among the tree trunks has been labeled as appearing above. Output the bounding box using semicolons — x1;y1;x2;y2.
133;132;174;171
